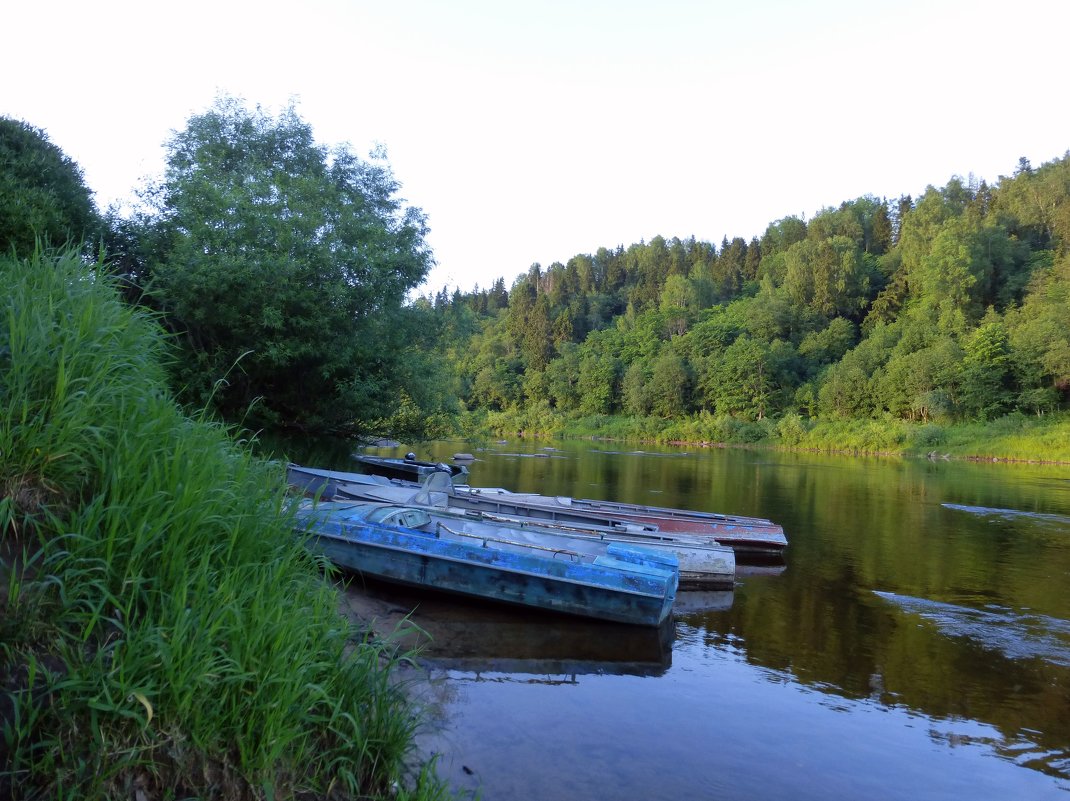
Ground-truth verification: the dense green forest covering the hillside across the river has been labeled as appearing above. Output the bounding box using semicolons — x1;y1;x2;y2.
424;154;1070;442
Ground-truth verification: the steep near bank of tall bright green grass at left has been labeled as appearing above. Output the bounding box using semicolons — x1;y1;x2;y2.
0;255;442;801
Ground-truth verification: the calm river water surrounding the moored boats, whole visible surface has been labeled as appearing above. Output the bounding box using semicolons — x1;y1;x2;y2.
325;441;1070;801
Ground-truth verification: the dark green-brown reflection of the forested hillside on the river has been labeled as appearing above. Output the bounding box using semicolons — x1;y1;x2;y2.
325;441;1070;777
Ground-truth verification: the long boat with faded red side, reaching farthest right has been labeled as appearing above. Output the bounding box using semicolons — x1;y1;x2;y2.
290;465;788;561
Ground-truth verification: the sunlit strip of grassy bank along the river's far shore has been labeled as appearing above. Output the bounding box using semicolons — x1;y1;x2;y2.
464;409;1070;463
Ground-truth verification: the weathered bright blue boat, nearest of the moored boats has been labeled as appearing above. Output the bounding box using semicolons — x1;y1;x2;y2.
297;502;678;626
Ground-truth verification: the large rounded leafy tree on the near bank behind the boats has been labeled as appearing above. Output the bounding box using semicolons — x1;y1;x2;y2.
136;98;431;433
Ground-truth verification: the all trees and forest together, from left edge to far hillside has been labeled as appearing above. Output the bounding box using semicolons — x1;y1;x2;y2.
0;97;1070;457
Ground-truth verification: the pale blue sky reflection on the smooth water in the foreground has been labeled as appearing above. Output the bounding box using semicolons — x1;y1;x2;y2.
422;612;1070;801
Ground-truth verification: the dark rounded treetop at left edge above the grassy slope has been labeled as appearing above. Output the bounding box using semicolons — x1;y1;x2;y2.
0;117;100;257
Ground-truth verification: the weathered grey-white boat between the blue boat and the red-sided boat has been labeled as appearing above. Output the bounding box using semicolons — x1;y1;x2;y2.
290;465;736;589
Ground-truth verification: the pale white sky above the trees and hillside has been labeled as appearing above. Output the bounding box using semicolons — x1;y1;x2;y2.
0;0;1070;292
